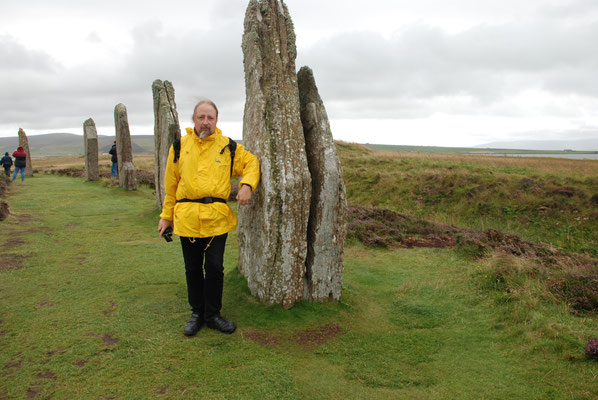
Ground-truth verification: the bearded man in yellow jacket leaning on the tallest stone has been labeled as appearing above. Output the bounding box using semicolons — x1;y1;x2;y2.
158;100;260;336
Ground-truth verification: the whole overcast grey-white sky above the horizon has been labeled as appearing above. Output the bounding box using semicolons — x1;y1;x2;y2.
0;0;598;146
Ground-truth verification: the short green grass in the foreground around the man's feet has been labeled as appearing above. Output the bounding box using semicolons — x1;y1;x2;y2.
0;175;598;399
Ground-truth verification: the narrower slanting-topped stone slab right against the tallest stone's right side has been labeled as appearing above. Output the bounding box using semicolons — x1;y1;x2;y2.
297;67;347;301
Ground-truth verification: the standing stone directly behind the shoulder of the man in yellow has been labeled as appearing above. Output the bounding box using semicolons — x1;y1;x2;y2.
152;79;181;209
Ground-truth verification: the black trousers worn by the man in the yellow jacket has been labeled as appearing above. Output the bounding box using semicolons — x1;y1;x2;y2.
181;233;228;320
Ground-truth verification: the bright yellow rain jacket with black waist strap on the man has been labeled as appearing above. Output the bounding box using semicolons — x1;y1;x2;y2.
160;128;260;238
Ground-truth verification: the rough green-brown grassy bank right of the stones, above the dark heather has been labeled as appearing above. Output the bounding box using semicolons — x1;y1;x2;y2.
338;143;598;256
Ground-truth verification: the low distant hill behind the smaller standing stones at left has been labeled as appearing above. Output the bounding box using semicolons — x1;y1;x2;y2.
0;133;154;158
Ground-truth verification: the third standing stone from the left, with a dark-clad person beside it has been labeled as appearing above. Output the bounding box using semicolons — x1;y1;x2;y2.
114;104;137;190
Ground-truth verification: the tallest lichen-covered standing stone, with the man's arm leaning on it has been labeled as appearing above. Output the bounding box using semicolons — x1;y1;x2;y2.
238;0;311;308
